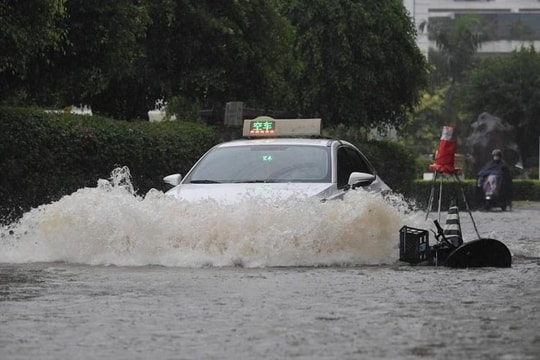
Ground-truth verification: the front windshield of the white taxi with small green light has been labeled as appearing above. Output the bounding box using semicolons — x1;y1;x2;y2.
184;145;331;184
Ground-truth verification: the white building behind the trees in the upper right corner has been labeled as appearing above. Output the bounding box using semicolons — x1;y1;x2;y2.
403;0;540;56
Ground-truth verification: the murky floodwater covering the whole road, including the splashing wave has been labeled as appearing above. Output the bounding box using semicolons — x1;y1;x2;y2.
0;173;540;360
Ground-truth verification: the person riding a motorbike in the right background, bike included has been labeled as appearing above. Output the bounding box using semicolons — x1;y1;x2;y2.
477;149;512;210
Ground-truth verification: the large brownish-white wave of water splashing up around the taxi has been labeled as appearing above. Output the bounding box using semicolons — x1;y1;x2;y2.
0;168;425;267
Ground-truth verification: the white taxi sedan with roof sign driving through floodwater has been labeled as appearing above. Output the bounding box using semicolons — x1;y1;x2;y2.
164;117;389;203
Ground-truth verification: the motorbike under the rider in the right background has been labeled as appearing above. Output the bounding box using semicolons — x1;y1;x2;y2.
477;172;512;211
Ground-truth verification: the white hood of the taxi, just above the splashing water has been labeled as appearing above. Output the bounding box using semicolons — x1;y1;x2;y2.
166;183;332;203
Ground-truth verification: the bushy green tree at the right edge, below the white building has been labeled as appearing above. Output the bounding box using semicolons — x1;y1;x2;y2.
461;47;540;167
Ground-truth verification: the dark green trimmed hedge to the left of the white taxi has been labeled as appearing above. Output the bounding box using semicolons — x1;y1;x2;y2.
0;107;219;222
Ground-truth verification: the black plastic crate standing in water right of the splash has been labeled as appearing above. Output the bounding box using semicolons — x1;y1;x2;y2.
399;226;430;264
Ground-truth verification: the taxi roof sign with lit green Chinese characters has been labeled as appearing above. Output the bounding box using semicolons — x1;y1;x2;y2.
243;116;321;137
